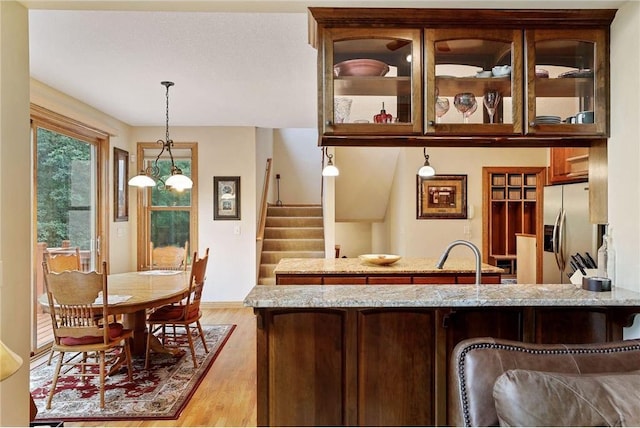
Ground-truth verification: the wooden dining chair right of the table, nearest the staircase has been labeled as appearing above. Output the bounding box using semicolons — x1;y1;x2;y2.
144;248;209;368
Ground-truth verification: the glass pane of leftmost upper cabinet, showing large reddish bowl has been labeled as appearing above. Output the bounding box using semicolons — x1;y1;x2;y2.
333;38;413;124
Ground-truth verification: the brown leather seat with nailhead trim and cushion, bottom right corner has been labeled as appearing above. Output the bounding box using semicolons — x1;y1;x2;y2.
448;338;640;426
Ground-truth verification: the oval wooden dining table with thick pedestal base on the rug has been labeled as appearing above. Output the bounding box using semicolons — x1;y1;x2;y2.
38;270;190;355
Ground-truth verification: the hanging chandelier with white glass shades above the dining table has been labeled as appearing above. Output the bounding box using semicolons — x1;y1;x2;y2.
129;81;193;192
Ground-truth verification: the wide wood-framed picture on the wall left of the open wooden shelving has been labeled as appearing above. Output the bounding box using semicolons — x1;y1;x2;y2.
417;175;467;219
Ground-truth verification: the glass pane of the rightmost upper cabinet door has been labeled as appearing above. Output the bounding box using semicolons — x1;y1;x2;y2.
535;40;595;125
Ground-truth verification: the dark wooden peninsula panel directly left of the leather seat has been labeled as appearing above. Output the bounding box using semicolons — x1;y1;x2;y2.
357;308;436;426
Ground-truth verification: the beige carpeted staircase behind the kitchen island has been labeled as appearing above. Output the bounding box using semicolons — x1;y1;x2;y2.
258;205;324;285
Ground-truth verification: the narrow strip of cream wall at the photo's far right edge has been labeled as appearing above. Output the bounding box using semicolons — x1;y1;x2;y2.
608;1;640;339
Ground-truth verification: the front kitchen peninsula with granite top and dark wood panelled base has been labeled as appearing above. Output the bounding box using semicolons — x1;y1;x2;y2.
245;284;640;426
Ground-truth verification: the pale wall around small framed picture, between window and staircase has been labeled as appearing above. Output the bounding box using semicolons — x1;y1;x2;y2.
131;127;263;302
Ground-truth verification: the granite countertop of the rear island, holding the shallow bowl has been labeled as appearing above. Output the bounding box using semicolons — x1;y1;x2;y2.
274;257;504;275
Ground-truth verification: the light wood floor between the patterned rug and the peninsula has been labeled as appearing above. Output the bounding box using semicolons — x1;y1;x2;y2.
36;307;257;427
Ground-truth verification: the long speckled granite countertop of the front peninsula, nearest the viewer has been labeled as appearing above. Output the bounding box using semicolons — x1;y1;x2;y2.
244;284;640;308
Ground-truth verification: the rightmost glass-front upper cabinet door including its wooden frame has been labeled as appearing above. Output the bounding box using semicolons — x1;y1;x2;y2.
525;29;609;136
